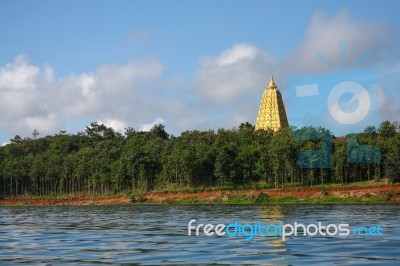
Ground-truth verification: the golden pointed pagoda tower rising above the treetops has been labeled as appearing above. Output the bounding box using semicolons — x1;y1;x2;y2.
255;77;289;131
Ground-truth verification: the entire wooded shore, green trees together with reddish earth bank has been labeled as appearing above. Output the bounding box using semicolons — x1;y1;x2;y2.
0;121;400;205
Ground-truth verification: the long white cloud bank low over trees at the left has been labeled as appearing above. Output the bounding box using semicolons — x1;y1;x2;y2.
0;56;167;137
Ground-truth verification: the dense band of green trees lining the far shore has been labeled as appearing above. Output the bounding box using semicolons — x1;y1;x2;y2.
0;121;400;196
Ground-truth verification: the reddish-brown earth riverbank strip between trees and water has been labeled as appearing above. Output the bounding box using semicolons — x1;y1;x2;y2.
0;185;400;206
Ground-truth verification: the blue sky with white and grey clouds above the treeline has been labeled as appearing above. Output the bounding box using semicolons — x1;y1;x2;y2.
0;0;400;143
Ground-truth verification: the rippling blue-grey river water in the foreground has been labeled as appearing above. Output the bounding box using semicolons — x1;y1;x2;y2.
0;205;400;265
